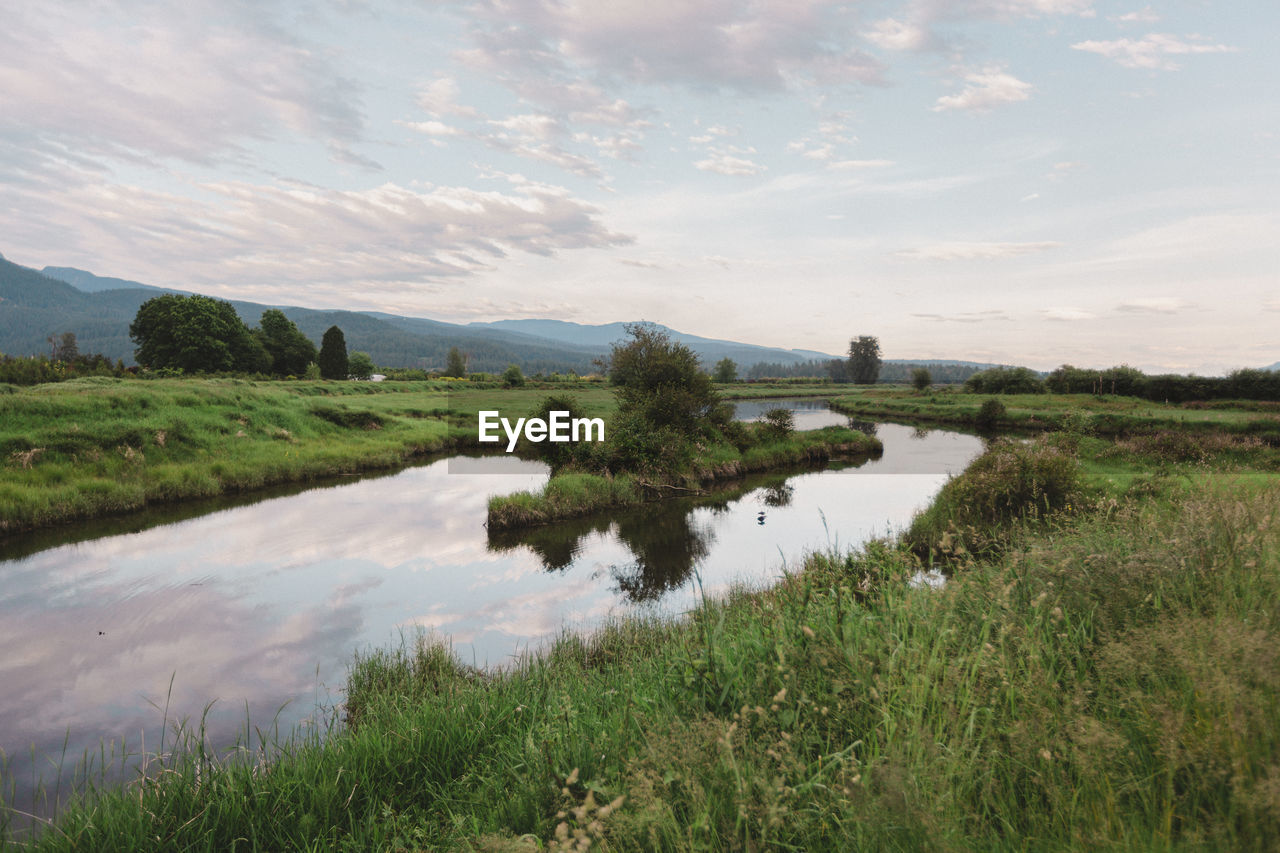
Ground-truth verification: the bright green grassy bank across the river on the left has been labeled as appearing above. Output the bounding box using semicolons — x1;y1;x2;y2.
0;378;613;534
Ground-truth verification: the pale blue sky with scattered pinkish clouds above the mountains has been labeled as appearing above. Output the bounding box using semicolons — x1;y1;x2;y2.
0;0;1280;374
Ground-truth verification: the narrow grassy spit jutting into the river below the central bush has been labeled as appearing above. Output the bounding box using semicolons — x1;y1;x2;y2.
486;428;881;530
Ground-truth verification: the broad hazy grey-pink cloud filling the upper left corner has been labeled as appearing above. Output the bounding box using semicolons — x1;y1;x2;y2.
0;0;367;164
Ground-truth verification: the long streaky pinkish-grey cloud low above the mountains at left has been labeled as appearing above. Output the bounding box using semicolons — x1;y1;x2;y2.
0;167;631;297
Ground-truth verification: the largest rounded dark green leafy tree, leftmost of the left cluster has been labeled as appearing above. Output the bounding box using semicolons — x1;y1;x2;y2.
129;293;271;373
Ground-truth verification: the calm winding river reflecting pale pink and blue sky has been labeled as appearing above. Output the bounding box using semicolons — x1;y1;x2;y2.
0;400;982;812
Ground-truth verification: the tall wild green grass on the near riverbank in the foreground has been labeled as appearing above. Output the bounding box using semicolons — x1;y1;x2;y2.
7;471;1280;850
